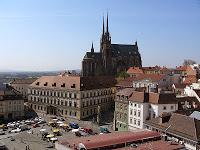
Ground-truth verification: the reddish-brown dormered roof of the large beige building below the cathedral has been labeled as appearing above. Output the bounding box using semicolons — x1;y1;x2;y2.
30;75;116;90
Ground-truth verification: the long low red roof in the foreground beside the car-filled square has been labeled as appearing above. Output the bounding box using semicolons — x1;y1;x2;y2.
59;131;160;150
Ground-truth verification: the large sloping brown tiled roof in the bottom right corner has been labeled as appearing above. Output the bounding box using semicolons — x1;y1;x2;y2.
145;113;200;141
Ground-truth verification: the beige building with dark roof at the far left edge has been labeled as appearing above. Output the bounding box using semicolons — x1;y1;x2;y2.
0;85;24;120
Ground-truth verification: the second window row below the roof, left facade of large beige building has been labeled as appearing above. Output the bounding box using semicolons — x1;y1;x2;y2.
30;96;77;107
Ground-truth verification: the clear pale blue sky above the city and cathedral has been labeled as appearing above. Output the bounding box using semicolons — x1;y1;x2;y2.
0;0;200;71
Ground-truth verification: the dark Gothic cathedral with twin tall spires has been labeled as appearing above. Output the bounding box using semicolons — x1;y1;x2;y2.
82;15;142;76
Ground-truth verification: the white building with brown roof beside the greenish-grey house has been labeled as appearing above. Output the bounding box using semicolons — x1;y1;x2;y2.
128;91;178;130
